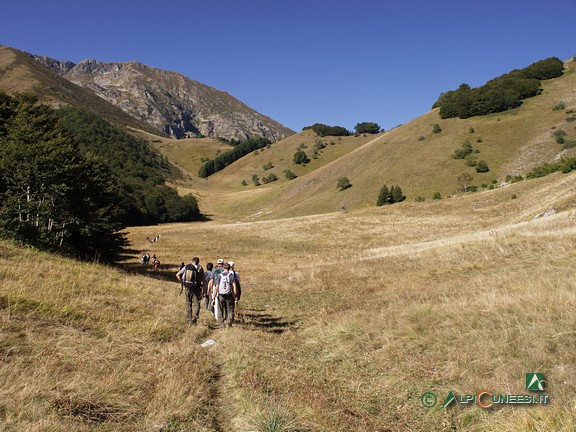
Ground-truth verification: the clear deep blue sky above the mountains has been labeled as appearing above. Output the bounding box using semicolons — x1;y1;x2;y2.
0;0;576;131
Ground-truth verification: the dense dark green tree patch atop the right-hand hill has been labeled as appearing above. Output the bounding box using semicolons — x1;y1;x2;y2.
432;57;564;119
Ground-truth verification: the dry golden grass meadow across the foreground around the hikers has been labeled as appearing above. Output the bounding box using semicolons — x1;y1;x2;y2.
0;170;576;432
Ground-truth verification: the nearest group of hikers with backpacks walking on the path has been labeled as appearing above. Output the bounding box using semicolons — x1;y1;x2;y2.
176;257;242;328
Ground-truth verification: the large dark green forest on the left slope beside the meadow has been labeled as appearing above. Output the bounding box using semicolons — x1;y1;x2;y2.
0;90;200;260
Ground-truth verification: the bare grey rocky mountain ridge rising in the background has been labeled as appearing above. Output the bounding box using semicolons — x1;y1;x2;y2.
32;55;294;141
